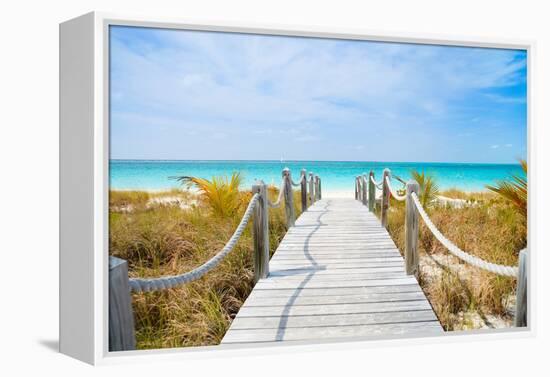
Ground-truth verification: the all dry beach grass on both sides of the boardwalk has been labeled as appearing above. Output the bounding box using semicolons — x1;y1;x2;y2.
109;173;527;349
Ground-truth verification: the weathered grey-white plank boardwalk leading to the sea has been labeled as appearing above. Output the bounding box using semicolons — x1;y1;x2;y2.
222;199;443;344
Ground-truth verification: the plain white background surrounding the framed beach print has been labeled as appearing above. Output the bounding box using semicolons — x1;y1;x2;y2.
0;0;550;377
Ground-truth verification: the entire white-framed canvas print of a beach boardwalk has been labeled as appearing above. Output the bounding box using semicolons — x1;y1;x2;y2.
60;13;534;363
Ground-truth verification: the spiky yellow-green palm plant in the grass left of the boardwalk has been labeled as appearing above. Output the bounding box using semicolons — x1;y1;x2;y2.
174;173;242;217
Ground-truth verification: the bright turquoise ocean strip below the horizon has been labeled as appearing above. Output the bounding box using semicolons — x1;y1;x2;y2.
109;160;522;192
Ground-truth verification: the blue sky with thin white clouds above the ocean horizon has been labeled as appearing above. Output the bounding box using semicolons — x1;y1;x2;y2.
111;26;527;163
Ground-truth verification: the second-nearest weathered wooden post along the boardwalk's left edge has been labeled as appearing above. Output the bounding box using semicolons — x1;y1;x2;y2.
252;181;269;282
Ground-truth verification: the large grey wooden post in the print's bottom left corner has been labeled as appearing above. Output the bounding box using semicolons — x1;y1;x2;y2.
109;256;136;351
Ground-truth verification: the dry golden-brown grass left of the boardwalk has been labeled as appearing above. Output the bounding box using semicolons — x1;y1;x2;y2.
109;190;300;349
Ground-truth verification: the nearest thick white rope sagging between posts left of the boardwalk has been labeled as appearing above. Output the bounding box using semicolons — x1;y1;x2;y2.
129;193;260;292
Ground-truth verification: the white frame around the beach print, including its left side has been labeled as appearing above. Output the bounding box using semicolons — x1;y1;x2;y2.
60;12;536;364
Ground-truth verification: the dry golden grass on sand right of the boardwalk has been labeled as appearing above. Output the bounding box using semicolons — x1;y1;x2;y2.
388;193;527;330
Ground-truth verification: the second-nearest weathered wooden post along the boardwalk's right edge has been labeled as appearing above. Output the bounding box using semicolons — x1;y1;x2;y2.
405;181;419;275
